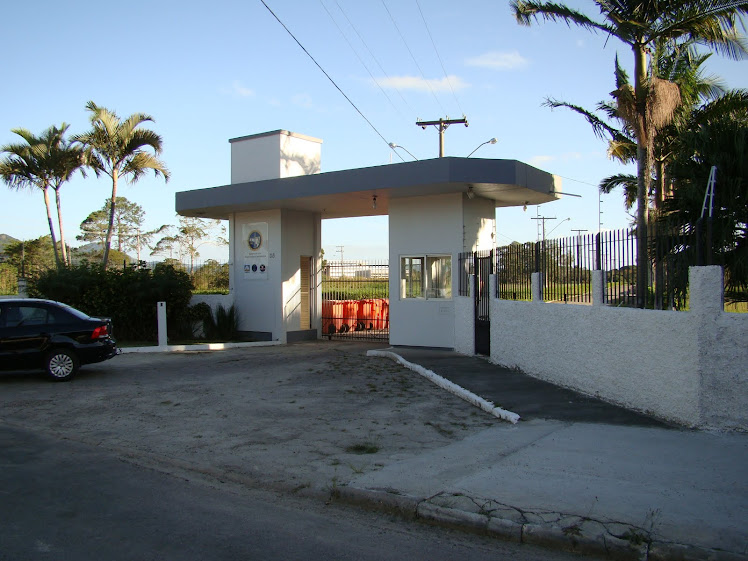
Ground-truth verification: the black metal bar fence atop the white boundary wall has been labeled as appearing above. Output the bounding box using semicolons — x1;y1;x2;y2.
486;222;748;309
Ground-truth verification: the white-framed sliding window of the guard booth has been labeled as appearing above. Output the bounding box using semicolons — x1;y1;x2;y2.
400;255;452;298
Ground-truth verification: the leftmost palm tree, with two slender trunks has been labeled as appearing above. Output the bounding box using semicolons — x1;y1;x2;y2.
0;123;82;266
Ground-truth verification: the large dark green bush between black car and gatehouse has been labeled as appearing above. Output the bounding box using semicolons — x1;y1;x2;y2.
29;262;192;341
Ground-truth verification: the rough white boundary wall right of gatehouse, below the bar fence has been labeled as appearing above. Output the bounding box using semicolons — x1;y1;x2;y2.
456;267;748;430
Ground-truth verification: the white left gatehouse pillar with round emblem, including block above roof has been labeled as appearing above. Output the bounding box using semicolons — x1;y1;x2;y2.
229;130;322;343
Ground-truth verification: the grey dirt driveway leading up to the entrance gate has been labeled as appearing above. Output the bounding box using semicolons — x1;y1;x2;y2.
0;341;500;491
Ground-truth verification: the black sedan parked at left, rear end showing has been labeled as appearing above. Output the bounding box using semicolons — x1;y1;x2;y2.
0;298;117;381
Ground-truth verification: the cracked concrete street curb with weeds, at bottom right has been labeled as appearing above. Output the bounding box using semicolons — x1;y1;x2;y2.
330;486;748;561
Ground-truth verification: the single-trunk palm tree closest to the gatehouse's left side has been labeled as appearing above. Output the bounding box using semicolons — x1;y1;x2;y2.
74;101;169;267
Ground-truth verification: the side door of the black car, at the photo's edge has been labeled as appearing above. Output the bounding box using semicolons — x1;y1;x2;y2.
0;302;49;370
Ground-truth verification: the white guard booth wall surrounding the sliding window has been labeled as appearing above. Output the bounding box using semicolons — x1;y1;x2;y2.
389;193;464;348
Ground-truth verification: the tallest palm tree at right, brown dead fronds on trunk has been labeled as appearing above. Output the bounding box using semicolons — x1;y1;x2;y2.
511;0;748;307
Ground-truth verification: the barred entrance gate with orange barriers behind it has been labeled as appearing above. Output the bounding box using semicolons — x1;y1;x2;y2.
322;261;390;341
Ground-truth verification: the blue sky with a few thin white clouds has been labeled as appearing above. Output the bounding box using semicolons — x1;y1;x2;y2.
0;0;748;260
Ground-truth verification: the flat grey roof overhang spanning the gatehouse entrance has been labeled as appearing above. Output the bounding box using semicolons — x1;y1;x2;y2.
176;158;562;220
